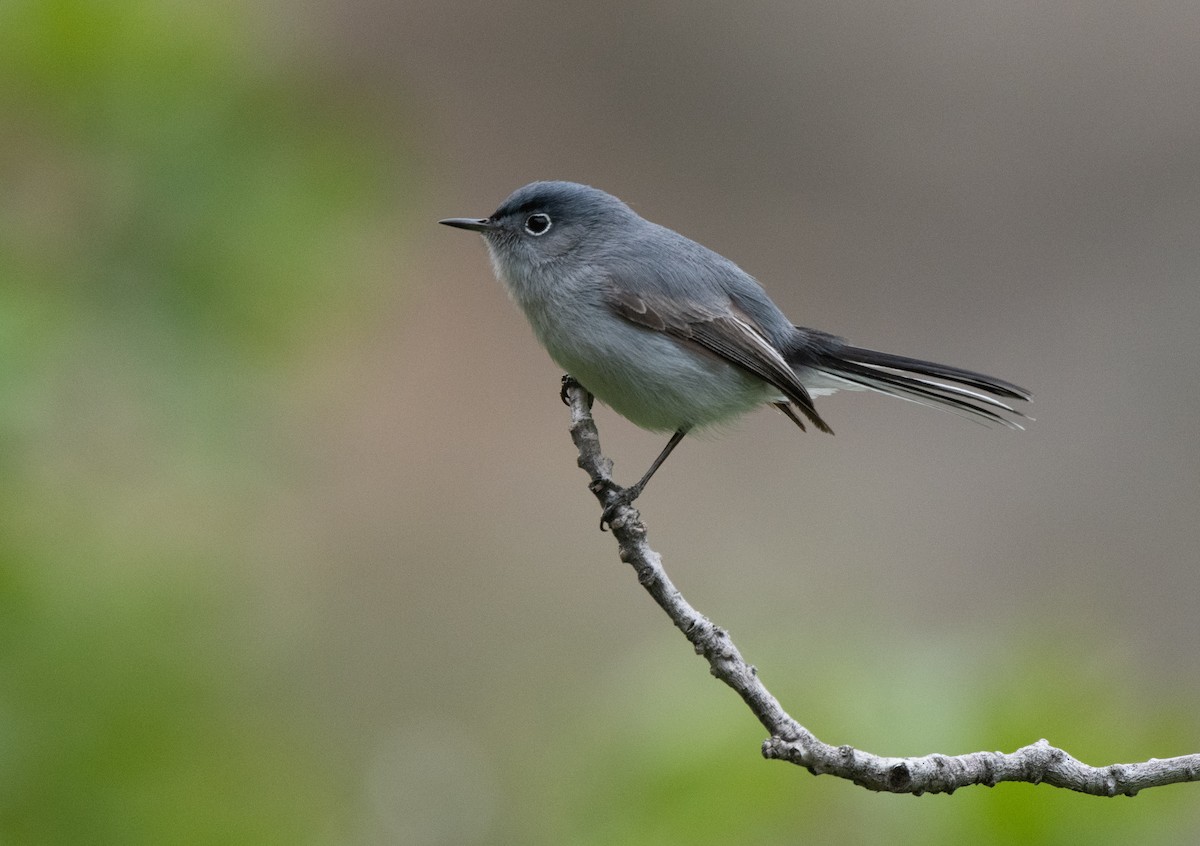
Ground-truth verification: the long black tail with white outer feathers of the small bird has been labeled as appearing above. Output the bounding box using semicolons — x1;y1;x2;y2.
788;326;1031;428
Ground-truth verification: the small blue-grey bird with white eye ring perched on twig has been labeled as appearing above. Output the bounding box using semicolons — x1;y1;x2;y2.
440;182;1030;518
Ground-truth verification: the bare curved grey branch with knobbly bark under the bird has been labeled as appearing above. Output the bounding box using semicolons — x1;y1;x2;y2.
563;383;1200;796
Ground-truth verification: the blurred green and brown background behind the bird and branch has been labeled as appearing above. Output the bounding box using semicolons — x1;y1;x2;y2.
0;0;1200;846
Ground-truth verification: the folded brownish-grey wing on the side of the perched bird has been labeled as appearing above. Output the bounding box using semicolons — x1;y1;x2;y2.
608;288;833;433
